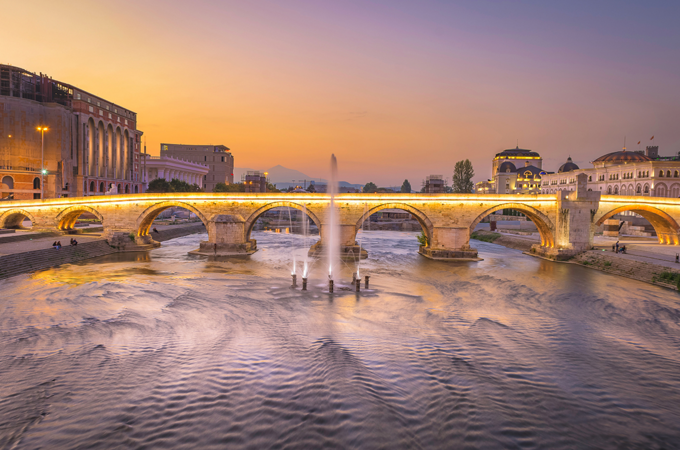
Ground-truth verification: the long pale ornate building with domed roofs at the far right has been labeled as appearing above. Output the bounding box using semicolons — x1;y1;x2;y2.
541;146;680;198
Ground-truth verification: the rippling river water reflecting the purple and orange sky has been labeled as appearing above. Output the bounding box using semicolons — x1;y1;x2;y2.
0;231;680;449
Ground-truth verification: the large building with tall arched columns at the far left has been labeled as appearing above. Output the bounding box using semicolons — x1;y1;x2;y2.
0;65;142;199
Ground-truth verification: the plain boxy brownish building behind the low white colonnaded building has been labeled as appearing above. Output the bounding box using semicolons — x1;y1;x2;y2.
161;144;234;192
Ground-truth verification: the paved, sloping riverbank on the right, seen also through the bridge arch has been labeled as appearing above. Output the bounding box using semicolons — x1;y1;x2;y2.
471;230;680;290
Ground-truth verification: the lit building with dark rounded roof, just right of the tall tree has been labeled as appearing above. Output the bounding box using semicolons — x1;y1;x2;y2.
475;147;546;194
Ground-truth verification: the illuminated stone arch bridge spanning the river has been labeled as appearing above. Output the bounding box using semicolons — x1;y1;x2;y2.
0;174;680;260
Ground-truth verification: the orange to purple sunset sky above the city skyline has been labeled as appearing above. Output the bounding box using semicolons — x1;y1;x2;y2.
0;0;680;188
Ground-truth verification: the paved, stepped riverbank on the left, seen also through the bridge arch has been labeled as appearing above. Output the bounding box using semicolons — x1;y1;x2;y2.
0;222;205;279
